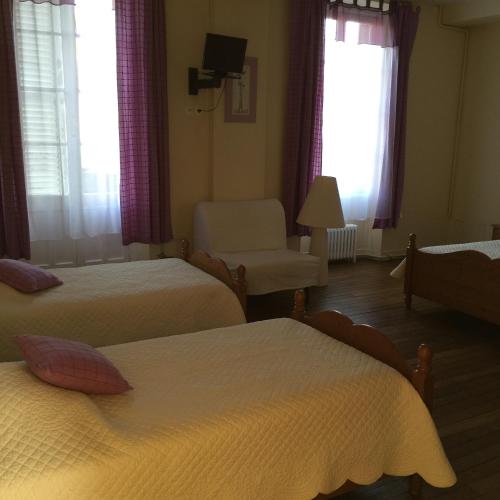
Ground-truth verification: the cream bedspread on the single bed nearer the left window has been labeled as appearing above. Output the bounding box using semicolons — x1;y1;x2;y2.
0;259;245;361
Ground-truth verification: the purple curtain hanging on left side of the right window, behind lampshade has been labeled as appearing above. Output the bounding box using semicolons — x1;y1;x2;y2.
282;0;327;236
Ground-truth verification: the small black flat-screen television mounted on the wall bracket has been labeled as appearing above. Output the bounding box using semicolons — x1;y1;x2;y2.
203;33;247;74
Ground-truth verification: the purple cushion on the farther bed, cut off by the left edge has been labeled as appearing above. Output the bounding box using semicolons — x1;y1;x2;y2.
0;259;62;293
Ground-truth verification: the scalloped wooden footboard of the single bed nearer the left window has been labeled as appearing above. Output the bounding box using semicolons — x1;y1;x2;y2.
181;239;247;316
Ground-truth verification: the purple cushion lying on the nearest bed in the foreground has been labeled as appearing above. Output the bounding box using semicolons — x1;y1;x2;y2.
15;335;132;394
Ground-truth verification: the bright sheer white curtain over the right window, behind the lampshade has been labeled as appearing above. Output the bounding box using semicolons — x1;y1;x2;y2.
323;19;394;226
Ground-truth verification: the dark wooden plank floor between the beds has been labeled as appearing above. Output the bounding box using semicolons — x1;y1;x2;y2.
248;260;500;500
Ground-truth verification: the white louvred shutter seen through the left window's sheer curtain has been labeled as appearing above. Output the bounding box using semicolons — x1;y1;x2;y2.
15;2;71;196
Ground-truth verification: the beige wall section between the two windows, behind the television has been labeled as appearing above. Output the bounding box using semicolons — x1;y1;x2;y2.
159;0;288;254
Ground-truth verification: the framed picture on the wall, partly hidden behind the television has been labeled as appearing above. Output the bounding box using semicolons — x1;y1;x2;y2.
224;57;257;123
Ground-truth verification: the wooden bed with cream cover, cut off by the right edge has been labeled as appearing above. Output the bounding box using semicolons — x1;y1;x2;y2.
391;228;500;325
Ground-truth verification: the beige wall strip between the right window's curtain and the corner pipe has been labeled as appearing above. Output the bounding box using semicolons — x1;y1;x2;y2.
382;2;465;256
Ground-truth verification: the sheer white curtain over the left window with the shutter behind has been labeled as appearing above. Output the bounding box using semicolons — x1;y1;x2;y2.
15;0;126;264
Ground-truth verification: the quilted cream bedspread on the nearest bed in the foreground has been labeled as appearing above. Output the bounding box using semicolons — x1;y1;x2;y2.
0;319;456;500
